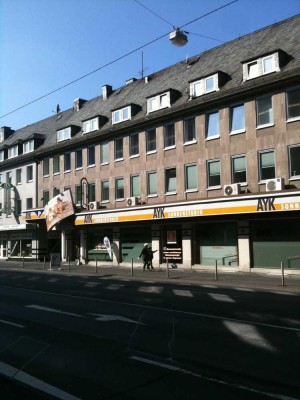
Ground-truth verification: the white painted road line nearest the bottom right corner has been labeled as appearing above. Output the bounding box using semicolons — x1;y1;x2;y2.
129;356;299;400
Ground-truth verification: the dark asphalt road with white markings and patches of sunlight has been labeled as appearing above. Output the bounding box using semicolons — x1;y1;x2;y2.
0;270;300;400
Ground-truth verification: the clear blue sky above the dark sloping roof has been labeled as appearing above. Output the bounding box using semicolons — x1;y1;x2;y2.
0;0;300;129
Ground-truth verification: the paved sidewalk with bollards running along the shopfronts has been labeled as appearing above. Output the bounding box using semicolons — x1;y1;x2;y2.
0;260;300;294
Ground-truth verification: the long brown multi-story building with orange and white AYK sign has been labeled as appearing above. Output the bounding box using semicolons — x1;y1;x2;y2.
0;15;300;270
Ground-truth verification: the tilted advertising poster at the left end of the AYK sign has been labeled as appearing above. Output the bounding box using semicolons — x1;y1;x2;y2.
44;190;75;231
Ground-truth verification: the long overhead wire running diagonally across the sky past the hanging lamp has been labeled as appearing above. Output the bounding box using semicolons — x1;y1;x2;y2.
0;0;239;119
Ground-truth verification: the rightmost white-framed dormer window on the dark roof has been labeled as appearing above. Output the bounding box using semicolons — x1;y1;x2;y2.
243;52;280;81
